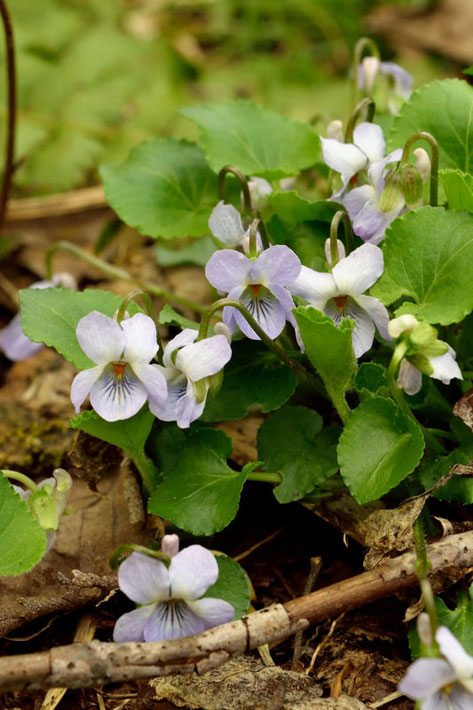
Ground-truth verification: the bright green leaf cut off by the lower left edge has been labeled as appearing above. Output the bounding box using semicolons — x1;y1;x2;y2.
0;471;46;575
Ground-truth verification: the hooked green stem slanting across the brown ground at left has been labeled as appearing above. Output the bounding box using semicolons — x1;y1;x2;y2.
46;241;207;313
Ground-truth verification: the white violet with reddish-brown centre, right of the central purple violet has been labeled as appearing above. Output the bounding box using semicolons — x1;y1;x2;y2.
289;244;392;357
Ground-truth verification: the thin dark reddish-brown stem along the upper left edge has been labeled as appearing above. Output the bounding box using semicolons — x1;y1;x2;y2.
0;0;16;228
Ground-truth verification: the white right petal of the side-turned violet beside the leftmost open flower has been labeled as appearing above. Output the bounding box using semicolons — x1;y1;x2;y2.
175;335;232;382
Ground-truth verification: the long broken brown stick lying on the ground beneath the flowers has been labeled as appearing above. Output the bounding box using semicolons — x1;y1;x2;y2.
0;531;473;692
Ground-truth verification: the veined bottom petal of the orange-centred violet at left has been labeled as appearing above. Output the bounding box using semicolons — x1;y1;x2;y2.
90;365;148;422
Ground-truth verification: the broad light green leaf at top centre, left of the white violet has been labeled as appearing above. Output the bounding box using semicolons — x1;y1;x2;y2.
181;100;320;179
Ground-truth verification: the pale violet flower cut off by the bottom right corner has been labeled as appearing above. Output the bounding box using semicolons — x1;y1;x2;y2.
399;626;473;710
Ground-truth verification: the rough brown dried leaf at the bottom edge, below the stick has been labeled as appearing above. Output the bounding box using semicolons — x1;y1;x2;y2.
151;656;366;710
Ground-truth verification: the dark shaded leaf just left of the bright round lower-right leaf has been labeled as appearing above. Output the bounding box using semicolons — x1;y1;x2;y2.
258;407;340;503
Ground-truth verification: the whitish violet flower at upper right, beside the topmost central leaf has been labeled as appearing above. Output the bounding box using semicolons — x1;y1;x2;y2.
320;121;386;200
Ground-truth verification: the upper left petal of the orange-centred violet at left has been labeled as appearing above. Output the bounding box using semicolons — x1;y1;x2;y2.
76;311;126;365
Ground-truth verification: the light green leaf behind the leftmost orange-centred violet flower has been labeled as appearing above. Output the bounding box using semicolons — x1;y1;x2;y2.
20;288;139;370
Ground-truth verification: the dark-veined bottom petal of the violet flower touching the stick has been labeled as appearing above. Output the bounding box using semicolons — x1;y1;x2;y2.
144;600;206;642
